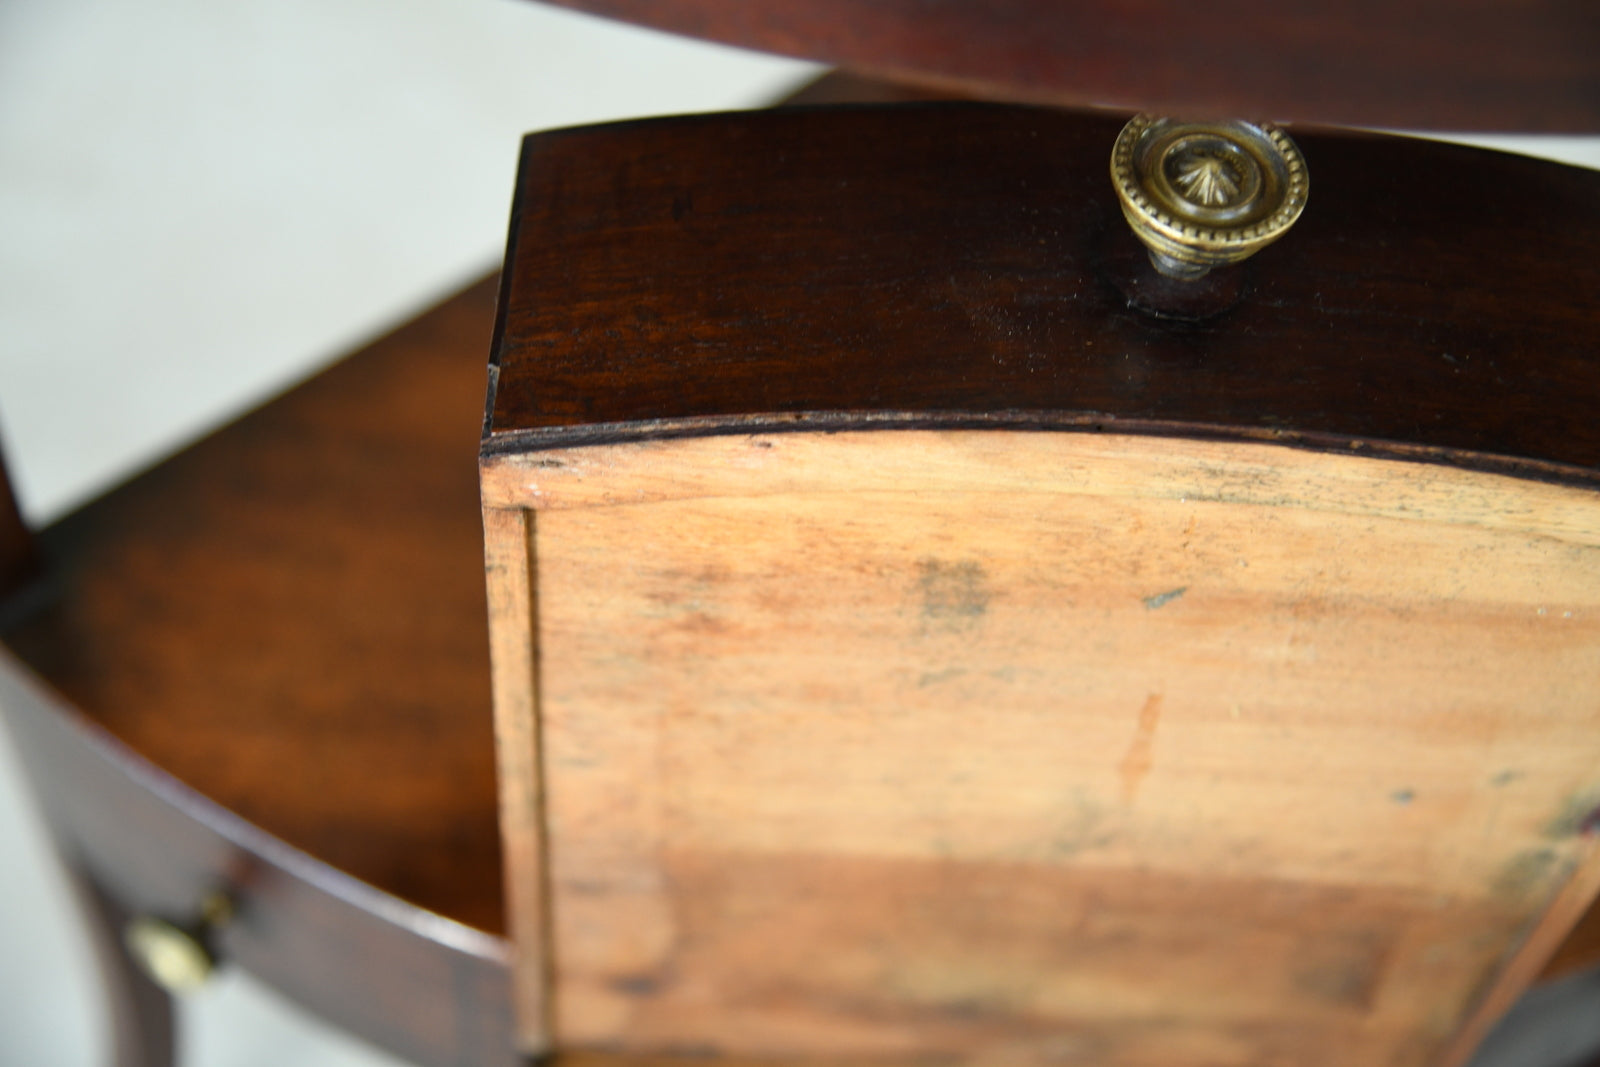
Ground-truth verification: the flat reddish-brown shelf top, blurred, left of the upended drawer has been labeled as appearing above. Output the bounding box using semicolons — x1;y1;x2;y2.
3;282;504;933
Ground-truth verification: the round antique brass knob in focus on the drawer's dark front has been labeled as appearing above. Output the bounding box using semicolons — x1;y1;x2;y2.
1110;115;1310;278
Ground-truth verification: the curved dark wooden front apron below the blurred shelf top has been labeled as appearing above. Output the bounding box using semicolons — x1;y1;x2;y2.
0;668;520;1067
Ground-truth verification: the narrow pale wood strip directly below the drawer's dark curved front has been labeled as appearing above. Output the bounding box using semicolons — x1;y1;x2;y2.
482;430;1600;544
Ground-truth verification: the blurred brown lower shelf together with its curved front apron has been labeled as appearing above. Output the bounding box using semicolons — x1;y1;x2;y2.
0;278;515;1067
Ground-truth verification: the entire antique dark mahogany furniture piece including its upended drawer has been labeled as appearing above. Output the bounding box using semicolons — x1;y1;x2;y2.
9;8;1600;1064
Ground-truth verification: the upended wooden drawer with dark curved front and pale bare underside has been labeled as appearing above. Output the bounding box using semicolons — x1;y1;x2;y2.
480;106;1600;1067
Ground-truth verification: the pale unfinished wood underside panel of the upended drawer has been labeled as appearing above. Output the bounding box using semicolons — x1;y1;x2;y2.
485;432;1600;1067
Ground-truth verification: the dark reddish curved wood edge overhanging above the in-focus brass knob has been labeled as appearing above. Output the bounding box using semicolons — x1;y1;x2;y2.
540;0;1600;131
